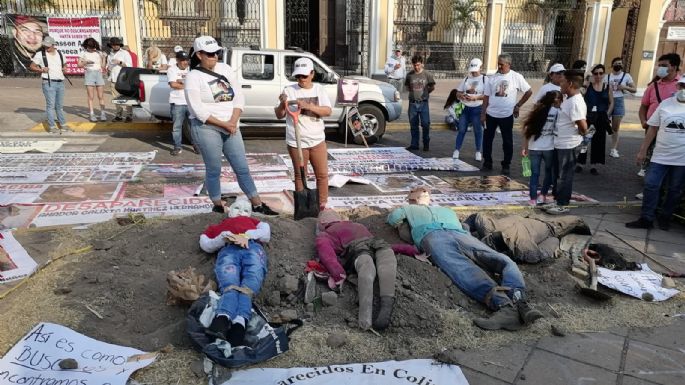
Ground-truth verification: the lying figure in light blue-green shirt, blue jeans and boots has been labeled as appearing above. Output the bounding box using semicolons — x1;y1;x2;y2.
388;187;542;330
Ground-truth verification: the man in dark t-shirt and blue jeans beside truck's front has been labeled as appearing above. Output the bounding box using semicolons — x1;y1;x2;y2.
404;55;435;151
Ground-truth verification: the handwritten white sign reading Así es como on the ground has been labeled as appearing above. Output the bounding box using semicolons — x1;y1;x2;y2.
0;323;156;385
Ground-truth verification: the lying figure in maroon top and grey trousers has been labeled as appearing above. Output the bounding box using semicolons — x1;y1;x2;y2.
316;209;397;330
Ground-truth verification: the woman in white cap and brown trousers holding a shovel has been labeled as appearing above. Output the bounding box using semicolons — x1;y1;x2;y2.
275;58;332;211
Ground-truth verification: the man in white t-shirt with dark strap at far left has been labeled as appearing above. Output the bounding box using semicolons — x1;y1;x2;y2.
29;36;71;134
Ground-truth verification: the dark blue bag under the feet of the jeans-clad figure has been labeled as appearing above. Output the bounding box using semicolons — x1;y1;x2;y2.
186;293;303;368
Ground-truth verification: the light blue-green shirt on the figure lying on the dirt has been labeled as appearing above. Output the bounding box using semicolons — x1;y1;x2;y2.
388;205;466;247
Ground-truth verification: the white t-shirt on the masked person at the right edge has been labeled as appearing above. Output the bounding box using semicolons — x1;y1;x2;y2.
647;97;685;166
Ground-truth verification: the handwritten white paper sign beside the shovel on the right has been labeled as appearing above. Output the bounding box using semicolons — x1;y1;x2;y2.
597;263;679;302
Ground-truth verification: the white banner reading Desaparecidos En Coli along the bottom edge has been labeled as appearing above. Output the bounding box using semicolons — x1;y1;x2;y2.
222;359;468;385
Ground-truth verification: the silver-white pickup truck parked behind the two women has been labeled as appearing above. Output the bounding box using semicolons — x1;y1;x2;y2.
112;47;402;141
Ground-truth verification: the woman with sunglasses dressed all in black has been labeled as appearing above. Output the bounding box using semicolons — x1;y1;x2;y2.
576;64;614;175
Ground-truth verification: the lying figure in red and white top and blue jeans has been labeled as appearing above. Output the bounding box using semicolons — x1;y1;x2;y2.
200;200;271;347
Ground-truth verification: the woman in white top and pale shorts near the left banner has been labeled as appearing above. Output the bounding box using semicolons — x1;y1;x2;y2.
77;37;107;122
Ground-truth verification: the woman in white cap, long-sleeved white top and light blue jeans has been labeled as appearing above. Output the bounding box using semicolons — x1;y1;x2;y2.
185;36;278;215
